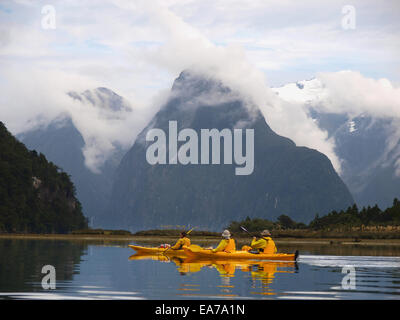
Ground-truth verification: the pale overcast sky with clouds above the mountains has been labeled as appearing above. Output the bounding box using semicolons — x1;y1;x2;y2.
0;0;400;174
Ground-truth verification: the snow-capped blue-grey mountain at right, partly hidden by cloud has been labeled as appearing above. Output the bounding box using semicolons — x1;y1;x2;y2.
271;78;400;207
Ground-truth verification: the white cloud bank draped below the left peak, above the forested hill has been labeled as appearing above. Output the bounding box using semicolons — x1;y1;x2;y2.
0;68;156;172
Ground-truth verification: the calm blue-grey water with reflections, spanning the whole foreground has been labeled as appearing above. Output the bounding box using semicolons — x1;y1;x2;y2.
0;239;400;299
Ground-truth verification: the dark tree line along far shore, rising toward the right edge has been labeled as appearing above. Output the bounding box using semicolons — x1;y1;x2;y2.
0;198;400;241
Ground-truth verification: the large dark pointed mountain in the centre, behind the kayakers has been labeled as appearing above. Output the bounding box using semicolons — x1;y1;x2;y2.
108;71;353;230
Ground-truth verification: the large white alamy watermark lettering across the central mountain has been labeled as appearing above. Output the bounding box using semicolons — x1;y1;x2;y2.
146;121;254;175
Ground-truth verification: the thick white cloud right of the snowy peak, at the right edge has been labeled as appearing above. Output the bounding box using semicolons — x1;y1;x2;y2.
311;71;400;176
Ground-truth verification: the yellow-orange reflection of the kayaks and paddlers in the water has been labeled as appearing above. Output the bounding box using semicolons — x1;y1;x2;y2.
129;254;298;297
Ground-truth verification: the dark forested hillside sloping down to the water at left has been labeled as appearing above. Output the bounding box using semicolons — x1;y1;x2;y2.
0;122;88;233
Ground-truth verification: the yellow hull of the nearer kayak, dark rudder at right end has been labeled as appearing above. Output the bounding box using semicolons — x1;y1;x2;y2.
183;247;298;261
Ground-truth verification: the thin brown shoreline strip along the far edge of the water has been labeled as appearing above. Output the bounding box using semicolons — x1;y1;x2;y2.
0;234;400;247
